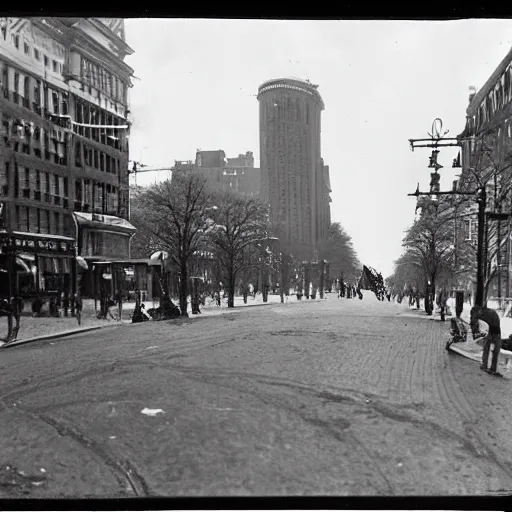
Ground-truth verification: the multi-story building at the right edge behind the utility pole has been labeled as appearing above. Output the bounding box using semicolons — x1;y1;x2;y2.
459;46;512;297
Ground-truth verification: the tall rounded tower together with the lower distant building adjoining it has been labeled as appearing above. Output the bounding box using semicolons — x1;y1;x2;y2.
173;78;332;260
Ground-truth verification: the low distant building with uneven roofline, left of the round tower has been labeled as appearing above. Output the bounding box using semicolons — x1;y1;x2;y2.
173;149;261;196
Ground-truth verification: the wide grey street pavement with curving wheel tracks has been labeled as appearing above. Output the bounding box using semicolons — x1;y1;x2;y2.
0;294;512;497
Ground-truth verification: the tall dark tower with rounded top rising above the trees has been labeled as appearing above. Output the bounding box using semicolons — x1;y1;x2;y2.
258;78;330;257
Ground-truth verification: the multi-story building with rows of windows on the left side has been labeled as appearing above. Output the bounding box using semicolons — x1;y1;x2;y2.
0;18;135;300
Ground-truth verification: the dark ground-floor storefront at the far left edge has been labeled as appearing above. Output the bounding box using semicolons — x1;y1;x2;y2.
0;231;77;300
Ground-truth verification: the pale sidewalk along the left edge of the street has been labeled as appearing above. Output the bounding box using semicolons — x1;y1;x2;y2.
0;295;320;347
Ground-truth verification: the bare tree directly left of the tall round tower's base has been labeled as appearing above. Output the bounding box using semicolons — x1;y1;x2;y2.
210;191;269;308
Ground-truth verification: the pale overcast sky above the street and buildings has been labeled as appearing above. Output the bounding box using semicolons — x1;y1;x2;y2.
125;19;512;277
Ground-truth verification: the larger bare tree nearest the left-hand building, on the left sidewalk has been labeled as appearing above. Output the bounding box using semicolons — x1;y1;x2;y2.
141;173;212;316
